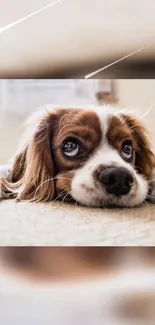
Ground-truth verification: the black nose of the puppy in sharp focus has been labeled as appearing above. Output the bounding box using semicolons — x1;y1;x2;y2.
99;167;134;196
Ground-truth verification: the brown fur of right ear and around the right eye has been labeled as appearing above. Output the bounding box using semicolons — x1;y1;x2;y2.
107;114;155;179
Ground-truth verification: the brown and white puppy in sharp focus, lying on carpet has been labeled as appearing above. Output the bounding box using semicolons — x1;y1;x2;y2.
0;106;155;207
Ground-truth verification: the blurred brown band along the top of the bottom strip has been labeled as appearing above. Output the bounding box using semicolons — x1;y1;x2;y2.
0;247;155;280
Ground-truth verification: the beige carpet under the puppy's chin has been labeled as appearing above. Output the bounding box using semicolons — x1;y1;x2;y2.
0;200;155;246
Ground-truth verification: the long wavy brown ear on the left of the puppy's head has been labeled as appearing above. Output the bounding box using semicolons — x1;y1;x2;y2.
3;113;55;202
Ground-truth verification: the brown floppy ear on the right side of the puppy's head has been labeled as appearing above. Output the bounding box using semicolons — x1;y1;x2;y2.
122;114;155;179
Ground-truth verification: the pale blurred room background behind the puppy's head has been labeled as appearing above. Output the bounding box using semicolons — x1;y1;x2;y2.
0;79;155;164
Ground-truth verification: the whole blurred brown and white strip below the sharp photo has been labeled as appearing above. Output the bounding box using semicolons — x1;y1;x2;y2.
0;247;155;325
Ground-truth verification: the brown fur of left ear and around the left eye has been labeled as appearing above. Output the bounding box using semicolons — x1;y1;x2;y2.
0;109;101;202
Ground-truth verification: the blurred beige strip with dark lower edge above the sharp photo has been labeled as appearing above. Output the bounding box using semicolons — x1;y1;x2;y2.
0;0;155;78
